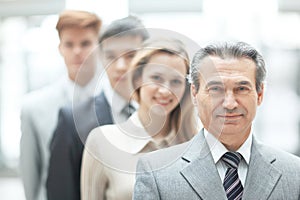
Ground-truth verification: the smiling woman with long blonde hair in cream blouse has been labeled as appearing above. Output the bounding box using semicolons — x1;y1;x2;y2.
81;39;197;200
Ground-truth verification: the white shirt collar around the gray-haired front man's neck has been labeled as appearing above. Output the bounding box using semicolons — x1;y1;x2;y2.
204;129;253;165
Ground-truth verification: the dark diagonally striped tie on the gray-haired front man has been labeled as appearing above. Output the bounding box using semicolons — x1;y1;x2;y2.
222;152;243;200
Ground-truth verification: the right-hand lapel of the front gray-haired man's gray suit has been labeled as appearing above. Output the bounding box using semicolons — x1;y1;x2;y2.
243;138;281;199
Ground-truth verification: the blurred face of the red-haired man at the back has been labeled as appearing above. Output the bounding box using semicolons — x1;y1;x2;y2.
59;28;98;85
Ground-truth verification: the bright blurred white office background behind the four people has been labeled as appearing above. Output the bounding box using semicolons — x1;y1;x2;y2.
0;0;300;200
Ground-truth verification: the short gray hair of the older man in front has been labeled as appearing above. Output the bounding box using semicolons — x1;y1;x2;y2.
190;42;266;92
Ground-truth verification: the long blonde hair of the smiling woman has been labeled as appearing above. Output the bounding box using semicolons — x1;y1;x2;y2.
129;38;197;141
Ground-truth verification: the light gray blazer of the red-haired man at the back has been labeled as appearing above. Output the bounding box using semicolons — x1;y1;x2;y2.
20;79;71;200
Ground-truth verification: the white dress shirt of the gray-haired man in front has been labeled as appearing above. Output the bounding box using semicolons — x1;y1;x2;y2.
204;129;252;186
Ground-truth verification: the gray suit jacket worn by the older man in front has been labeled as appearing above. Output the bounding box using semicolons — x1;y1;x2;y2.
133;131;300;200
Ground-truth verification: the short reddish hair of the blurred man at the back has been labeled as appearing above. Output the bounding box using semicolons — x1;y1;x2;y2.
56;10;102;36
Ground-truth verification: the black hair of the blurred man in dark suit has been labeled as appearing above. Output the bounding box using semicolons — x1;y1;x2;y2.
99;16;149;44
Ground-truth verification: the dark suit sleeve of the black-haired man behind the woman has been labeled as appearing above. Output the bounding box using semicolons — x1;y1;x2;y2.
46;108;83;200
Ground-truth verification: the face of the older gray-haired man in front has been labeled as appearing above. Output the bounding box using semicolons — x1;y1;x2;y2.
192;56;263;143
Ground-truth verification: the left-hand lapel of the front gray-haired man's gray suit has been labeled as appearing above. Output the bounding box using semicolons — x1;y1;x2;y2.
181;130;226;200
